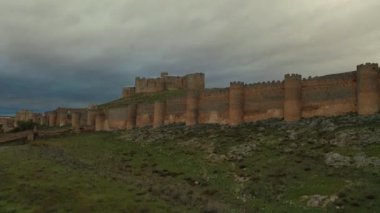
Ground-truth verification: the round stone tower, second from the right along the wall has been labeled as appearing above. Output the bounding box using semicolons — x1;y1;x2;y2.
284;74;302;121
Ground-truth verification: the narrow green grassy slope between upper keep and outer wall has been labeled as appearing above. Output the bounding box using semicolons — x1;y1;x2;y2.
98;90;186;109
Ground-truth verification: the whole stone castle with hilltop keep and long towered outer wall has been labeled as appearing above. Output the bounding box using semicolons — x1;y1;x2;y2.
13;63;380;131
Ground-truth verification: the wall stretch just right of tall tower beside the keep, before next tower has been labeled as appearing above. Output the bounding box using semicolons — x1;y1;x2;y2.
198;88;229;124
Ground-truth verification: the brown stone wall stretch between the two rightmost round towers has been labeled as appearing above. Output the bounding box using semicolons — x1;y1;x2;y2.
302;72;357;118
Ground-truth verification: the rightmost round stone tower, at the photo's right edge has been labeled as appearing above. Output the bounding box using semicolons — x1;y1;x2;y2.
356;63;379;115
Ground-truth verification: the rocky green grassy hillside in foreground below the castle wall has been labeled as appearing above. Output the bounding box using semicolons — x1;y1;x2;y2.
0;113;380;212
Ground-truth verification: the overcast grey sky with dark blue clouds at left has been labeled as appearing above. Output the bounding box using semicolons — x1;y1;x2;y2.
0;0;380;114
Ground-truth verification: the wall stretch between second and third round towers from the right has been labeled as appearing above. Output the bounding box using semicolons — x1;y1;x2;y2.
243;81;284;122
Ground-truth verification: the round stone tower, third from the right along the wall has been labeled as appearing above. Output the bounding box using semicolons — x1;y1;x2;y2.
229;82;244;126
